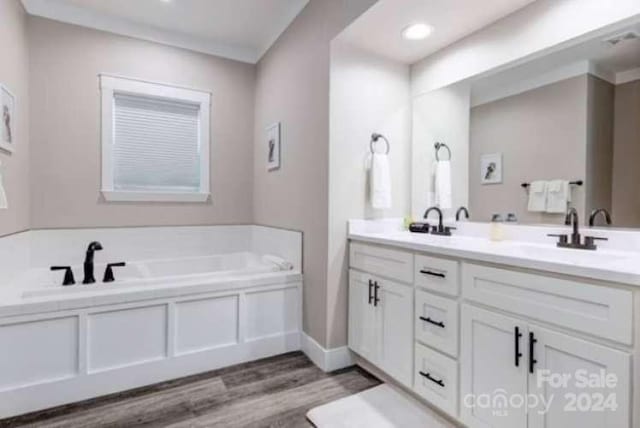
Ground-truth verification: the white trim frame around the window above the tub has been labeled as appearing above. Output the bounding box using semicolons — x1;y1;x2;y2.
99;74;211;202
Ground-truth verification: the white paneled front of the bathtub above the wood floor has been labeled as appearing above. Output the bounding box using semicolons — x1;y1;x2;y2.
0;281;302;418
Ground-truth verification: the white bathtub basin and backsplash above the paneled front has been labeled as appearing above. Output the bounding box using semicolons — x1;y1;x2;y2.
0;225;302;300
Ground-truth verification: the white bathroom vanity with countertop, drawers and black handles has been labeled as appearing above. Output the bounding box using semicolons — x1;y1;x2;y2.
349;221;640;428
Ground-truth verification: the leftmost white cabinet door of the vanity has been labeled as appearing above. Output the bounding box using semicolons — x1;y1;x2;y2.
349;271;377;363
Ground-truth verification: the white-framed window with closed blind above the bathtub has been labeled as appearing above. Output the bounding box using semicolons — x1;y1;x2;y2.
100;75;211;202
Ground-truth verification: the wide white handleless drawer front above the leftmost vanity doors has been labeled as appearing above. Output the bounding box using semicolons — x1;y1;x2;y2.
349;242;413;284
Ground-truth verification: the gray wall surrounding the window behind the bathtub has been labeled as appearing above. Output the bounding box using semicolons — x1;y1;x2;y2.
28;16;256;228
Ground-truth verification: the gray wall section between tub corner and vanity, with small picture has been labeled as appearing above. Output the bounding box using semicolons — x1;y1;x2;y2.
253;0;375;346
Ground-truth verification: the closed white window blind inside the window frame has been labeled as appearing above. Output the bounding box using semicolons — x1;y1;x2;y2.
112;93;201;192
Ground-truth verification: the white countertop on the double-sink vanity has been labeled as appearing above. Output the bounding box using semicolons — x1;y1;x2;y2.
349;228;640;286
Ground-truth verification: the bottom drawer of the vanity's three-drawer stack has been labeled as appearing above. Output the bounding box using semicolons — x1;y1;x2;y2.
413;343;458;416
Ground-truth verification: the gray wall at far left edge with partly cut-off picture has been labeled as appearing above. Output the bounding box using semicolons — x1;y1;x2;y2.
0;0;30;236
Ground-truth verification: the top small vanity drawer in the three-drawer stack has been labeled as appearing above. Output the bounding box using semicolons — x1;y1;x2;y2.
415;255;460;296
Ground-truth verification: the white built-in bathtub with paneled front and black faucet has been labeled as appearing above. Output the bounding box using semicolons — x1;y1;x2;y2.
0;226;303;419
